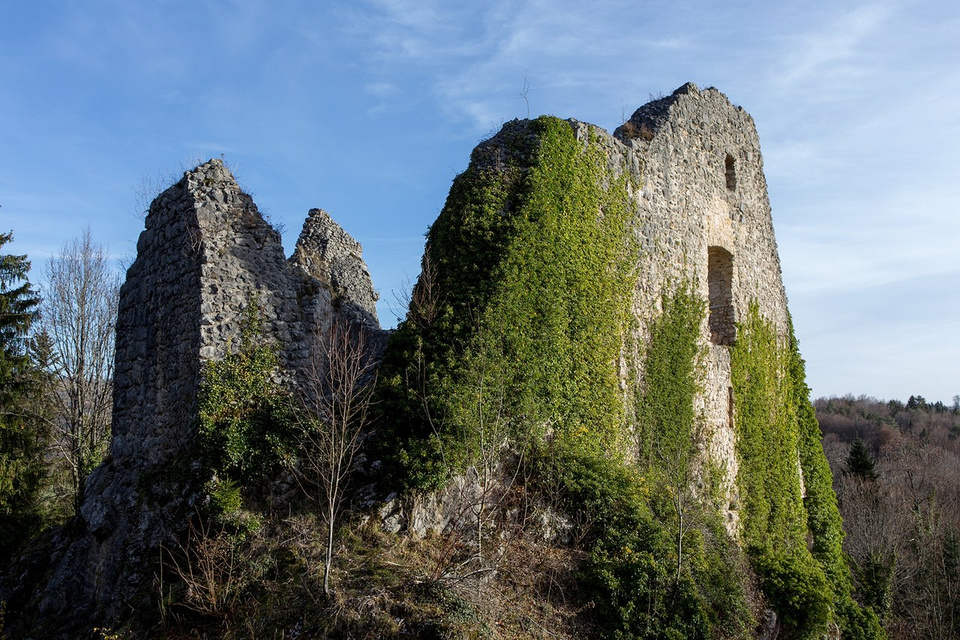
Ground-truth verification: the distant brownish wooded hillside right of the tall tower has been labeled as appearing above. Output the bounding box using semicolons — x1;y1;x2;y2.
814;395;960;638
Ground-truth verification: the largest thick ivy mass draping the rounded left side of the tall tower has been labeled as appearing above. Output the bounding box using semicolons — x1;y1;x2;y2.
379;117;636;488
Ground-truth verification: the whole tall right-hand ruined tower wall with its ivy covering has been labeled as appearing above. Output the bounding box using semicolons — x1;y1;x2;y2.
378;85;882;638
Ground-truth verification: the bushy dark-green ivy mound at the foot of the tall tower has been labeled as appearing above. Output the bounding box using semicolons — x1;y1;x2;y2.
535;442;752;638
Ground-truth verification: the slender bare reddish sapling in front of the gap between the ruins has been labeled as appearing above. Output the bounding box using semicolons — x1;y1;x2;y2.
300;321;375;594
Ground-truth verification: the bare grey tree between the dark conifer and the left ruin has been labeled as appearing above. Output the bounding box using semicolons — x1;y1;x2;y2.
41;227;120;508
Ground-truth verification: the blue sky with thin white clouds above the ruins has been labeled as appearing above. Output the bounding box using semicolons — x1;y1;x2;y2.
0;0;960;403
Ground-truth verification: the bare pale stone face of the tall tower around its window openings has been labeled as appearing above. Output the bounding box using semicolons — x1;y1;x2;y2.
614;84;789;532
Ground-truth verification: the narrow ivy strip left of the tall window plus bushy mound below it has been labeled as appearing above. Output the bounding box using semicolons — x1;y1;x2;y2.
536;283;752;638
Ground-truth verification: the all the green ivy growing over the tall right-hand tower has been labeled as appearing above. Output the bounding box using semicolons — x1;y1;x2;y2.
378;112;879;637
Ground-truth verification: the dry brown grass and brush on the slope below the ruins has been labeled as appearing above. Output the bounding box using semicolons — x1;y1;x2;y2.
144;488;591;639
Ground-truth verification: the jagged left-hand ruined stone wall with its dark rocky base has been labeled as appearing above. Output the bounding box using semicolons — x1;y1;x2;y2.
0;160;379;637
